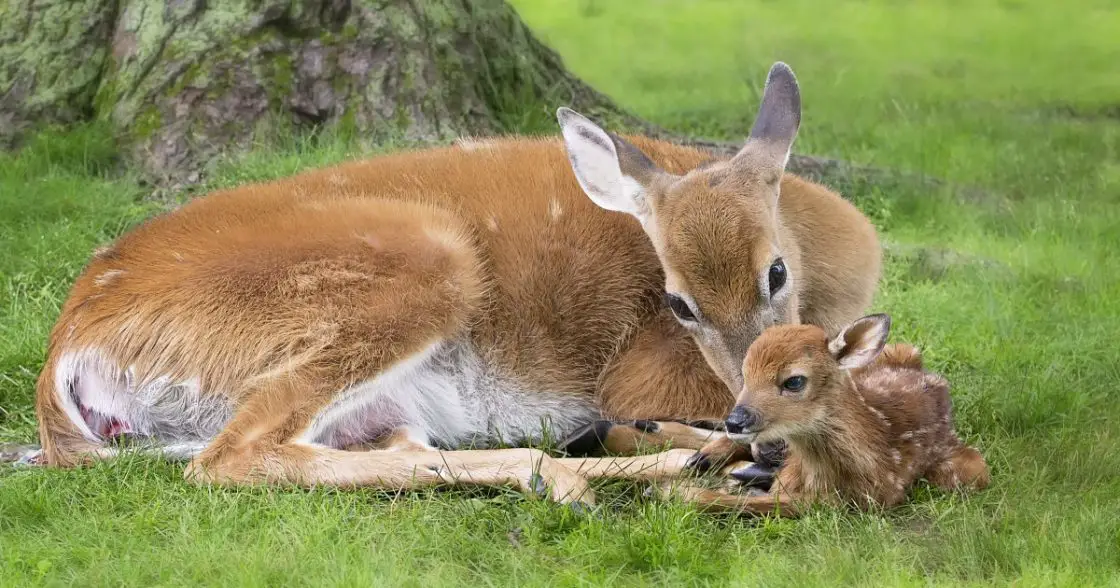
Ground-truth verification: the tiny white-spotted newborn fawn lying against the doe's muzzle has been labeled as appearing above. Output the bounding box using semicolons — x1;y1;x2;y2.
658;315;989;514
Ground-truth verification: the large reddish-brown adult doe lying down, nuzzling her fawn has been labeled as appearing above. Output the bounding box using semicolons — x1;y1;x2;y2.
30;64;880;501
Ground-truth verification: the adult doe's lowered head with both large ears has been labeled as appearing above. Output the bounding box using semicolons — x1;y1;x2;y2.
557;63;801;391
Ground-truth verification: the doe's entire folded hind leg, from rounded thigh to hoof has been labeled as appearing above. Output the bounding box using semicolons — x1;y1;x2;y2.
186;204;592;501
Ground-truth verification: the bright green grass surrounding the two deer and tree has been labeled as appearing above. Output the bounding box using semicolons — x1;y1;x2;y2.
0;0;1120;586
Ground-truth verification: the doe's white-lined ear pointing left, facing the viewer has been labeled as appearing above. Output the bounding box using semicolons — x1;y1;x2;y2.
557;108;664;223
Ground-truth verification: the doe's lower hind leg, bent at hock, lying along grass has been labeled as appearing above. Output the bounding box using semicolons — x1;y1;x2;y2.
185;366;595;504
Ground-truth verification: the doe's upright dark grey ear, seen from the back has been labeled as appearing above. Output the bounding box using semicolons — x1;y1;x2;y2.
735;62;801;169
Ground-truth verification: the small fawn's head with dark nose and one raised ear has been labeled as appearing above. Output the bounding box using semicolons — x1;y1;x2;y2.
727;315;890;444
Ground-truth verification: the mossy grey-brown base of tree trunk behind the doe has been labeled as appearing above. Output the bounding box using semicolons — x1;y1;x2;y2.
0;0;637;185
